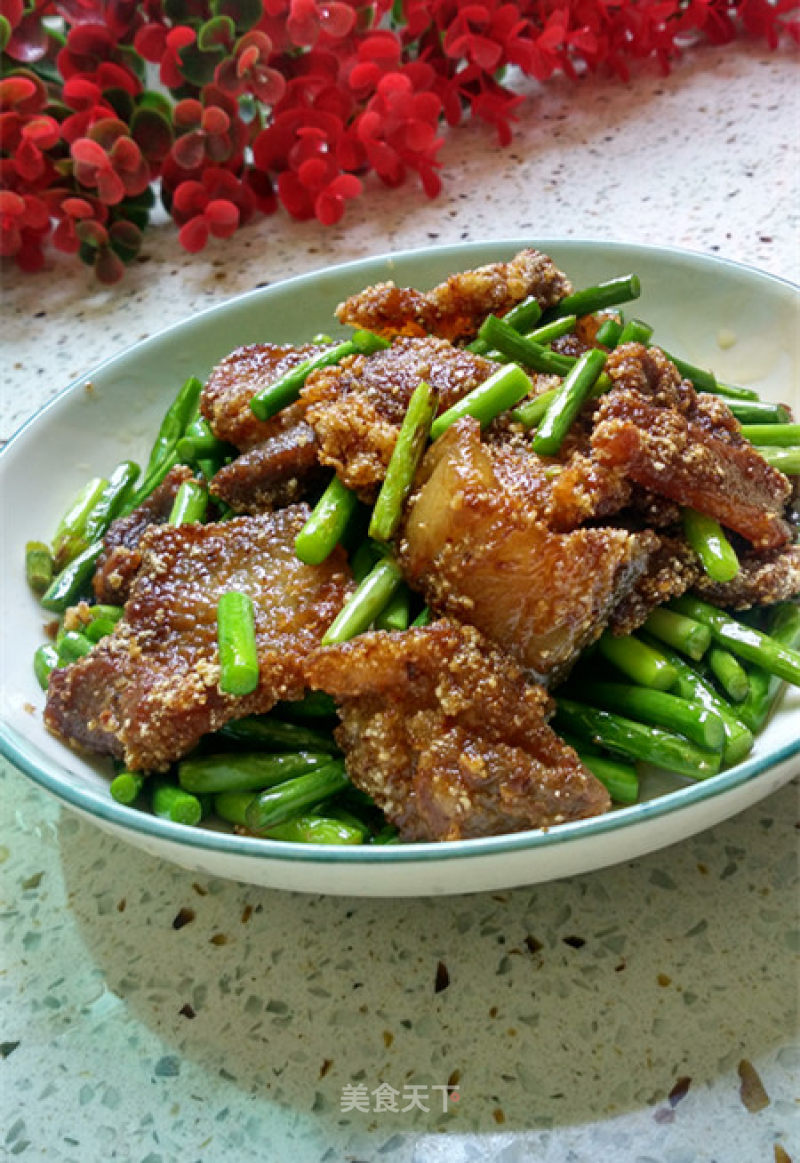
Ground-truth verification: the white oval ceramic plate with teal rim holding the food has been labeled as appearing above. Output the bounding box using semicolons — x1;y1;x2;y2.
0;240;800;897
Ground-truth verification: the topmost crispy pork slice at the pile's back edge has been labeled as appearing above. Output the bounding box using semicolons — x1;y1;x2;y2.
336;249;572;343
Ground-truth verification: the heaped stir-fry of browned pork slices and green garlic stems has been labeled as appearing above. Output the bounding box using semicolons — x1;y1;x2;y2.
28;249;800;843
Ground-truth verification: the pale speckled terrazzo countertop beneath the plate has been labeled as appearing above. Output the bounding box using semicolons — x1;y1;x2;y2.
0;40;800;1163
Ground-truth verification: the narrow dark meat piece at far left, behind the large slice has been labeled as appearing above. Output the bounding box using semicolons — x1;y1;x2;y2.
92;464;194;606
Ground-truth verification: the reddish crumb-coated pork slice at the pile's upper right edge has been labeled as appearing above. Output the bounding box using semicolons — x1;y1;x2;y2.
592;344;791;549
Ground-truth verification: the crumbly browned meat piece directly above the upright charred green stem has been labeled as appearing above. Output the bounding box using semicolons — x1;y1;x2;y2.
302;338;497;501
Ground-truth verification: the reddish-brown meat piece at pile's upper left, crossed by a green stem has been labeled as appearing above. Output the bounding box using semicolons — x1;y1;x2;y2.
200;343;323;450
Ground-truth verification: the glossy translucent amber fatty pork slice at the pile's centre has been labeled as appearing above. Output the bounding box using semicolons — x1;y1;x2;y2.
399;420;658;679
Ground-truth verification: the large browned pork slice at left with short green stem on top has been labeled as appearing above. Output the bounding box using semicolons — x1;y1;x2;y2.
44;505;350;771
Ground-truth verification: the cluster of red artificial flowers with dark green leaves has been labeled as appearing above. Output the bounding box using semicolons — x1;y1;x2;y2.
0;0;800;281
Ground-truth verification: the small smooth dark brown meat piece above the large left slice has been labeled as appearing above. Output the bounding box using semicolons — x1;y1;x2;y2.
209;420;323;513
